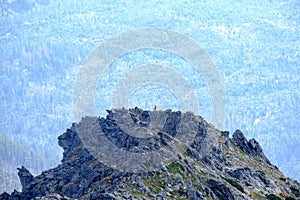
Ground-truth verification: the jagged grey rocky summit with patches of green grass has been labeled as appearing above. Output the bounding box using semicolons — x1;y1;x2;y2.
0;108;300;200
